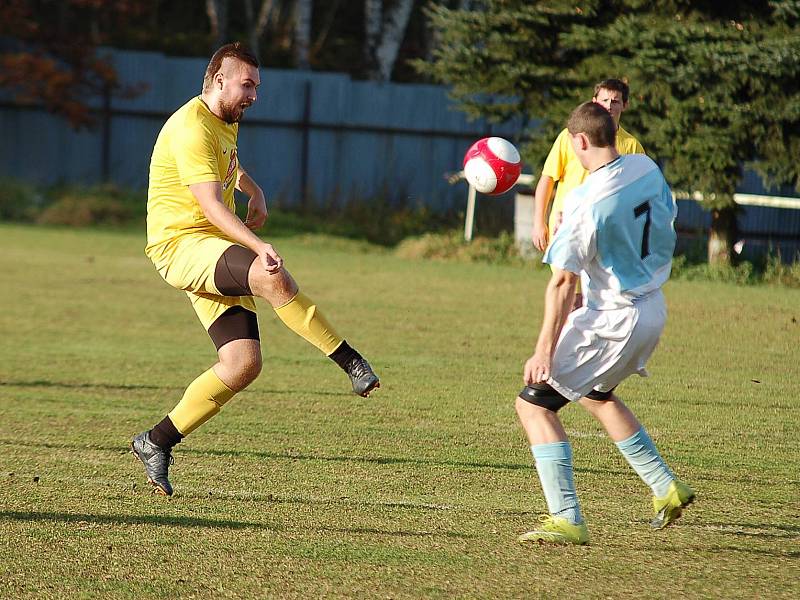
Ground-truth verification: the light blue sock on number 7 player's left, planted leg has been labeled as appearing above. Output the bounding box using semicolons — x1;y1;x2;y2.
531;442;583;525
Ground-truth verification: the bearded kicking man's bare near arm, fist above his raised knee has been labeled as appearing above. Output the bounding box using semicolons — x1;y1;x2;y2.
189;181;283;273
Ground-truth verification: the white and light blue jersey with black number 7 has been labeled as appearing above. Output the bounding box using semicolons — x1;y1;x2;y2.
543;154;677;310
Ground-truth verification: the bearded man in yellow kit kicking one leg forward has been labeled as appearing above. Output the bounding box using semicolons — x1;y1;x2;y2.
131;43;380;496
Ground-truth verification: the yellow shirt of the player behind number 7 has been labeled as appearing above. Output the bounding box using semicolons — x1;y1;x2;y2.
542;127;645;237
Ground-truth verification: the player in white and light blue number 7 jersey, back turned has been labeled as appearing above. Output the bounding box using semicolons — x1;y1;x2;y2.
516;102;695;544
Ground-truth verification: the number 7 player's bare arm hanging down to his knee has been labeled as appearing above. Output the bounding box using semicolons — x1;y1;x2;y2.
523;268;578;385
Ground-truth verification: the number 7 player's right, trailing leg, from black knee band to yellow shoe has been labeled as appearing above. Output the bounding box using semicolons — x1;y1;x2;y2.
580;392;695;529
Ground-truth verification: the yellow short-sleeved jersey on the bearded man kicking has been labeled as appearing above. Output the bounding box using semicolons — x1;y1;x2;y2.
145;97;239;259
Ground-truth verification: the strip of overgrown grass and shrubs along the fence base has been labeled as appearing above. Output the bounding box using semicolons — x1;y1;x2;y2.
0;179;800;288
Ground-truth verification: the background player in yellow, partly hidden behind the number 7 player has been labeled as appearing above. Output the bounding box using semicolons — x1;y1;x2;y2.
533;79;645;307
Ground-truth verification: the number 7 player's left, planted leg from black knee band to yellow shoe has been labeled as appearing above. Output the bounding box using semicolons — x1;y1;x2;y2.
516;384;589;544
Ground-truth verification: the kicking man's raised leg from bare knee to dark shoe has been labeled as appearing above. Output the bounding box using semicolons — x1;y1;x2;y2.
248;251;380;397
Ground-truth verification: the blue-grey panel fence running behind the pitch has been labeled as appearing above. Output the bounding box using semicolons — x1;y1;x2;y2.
0;50;800;257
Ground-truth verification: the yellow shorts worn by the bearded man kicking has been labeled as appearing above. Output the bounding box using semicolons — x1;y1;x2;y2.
146;233;256;331
